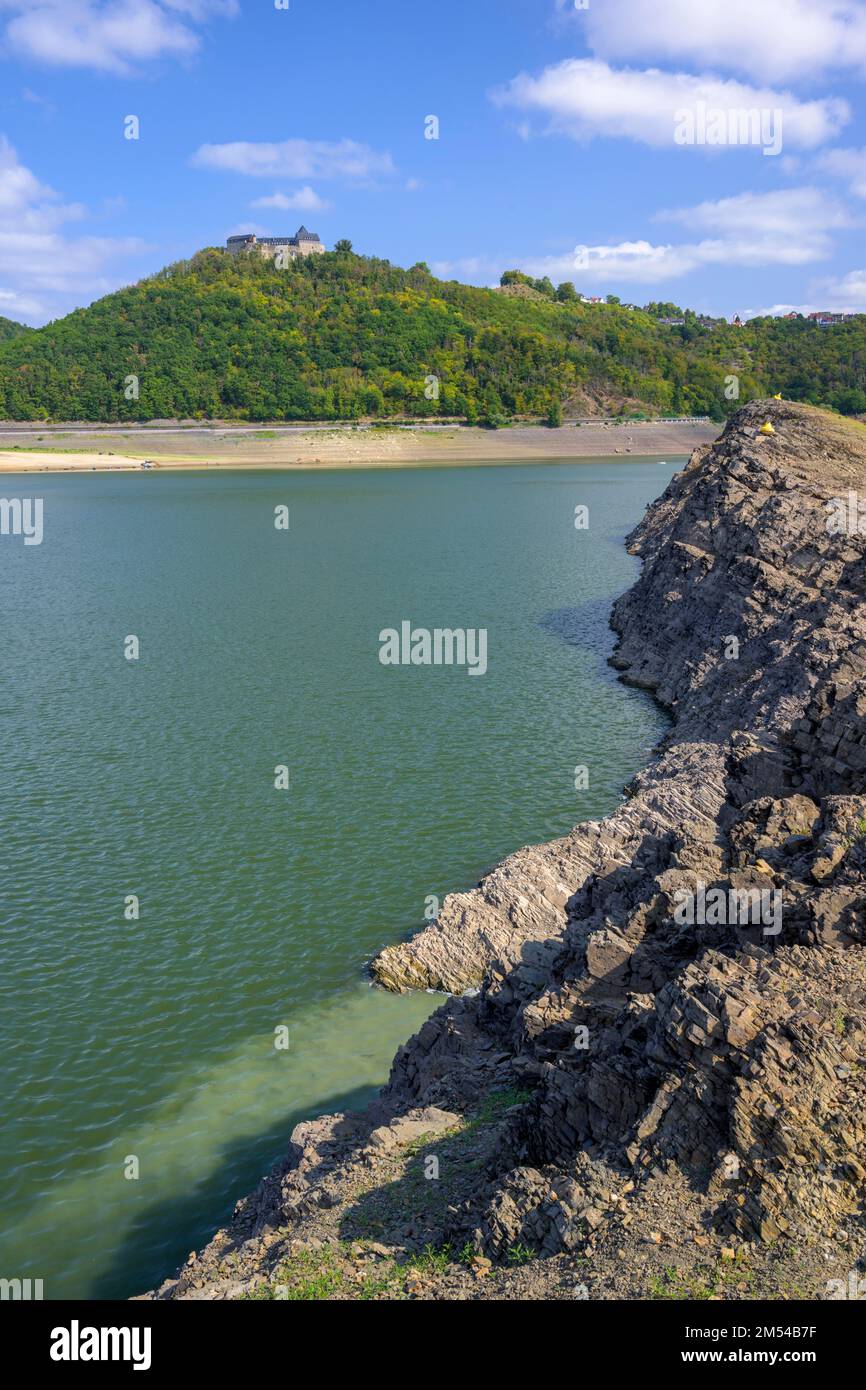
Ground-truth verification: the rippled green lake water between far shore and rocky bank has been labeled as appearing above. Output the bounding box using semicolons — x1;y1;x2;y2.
0;461;673;1298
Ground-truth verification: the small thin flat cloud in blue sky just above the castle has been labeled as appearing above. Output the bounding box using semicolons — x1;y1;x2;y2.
192;139;393;179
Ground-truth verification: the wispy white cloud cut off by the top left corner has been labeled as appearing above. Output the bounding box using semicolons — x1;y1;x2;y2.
0;0;239;72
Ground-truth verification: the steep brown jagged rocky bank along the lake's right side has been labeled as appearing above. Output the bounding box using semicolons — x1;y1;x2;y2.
146;400;866;1300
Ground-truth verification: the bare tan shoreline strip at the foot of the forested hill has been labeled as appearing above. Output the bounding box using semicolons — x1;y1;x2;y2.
0;421;721;473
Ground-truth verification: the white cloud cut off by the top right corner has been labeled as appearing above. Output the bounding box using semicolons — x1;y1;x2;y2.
575;0;866;82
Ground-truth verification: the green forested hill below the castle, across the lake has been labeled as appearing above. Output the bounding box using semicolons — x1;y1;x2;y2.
0;250;866;424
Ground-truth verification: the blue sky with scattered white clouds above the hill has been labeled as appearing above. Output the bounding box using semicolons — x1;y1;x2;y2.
0;0;866;324
